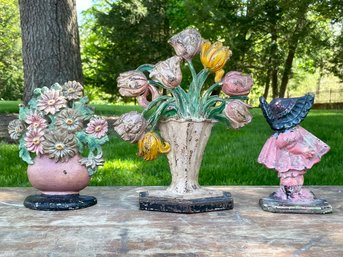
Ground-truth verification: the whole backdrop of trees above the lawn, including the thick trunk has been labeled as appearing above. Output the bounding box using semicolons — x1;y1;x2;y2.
0;0;343;100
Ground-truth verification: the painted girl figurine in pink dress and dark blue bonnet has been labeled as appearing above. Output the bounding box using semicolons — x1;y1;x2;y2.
258;93;332;213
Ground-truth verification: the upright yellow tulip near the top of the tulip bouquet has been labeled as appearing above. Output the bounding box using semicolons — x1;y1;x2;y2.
200;41;232;82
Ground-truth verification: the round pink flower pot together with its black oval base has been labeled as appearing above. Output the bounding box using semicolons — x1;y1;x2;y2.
24;155;97;211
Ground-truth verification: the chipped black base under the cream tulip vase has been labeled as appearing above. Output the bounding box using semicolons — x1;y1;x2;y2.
139;192;233;213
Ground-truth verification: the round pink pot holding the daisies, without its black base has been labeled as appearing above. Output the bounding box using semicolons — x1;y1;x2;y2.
27;155;90;195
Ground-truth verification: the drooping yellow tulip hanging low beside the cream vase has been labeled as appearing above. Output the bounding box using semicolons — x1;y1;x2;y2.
138;132;170;161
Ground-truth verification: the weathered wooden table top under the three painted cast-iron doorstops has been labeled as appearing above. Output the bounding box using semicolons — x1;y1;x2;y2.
0;186;343;257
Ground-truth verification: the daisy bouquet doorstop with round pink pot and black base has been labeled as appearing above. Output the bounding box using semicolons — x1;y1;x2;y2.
8;81;108;210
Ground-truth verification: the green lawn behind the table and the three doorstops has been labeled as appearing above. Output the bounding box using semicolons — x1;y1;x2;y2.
0;106;343;186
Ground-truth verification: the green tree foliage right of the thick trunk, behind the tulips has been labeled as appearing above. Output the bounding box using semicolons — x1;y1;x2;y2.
82;0;343;97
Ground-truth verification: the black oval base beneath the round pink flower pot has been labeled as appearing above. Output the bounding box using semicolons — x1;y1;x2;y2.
24;194;97;211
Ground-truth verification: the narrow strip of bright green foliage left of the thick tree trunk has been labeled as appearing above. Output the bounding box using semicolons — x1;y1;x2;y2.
0;0;23;100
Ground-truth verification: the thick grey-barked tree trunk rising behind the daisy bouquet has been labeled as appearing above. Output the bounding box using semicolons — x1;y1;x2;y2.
19;0;83;103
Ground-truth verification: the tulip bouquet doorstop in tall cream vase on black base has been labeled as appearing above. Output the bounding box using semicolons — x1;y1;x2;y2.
114;28;253;212
